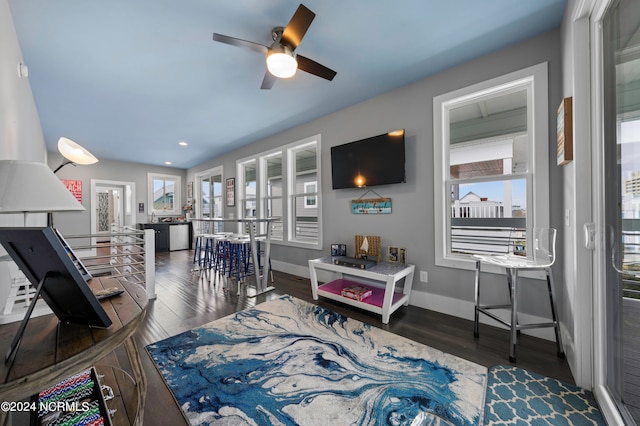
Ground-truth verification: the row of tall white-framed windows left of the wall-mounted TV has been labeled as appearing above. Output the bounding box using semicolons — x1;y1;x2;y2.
237;135;322;248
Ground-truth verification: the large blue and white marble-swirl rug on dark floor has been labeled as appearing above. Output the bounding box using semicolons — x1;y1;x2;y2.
147;296;487;425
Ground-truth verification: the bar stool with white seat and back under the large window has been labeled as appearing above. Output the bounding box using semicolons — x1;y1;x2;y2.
473;228;564;362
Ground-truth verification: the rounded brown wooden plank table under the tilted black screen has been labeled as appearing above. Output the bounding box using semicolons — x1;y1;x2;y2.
0;278;147;425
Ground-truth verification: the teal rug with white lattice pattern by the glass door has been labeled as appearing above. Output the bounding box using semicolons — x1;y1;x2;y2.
484;365;606;426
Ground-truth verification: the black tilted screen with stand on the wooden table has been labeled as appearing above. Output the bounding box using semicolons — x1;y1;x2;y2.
0;227;111;361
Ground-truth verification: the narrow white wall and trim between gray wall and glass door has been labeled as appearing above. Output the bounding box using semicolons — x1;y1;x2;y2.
560;0;594;388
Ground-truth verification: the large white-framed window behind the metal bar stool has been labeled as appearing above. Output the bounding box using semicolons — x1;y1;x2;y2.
434;63;549;269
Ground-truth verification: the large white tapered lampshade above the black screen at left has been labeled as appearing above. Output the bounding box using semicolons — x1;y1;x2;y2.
0;160;85;213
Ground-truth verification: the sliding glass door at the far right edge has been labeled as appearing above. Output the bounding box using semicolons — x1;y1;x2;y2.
600;0;640;424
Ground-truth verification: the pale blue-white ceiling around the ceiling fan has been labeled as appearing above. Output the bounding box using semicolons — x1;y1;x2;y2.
9;0;566;168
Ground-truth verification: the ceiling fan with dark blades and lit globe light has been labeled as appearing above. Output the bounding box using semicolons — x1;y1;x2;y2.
213;4;336;89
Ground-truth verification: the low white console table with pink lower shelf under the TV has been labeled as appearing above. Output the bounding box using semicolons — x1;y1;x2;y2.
309;256;416;324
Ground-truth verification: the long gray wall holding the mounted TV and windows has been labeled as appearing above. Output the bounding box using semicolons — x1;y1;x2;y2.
187;30;563;316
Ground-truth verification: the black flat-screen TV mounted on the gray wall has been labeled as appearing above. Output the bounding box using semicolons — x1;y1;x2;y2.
331;129;406;189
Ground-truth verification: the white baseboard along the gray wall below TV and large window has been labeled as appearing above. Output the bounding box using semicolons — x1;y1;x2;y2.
272;260;556;342
